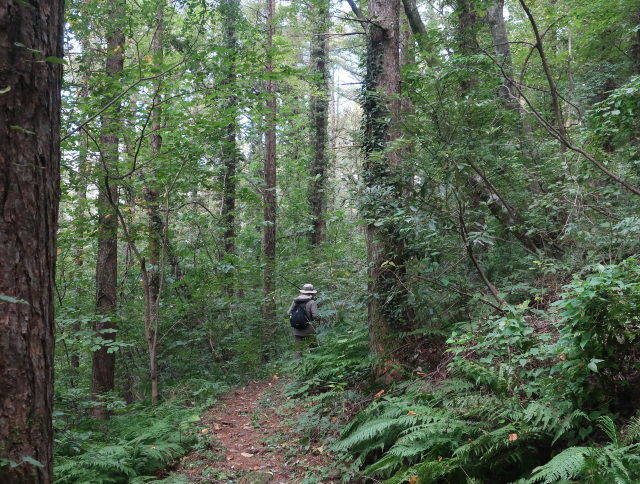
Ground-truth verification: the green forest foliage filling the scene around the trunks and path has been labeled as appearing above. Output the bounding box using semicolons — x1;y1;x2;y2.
51;0;640;484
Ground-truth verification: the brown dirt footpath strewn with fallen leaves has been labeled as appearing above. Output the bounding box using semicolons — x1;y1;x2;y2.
165;375;341;484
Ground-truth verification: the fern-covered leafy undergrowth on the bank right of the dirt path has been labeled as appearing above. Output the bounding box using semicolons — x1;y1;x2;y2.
290;259;640;484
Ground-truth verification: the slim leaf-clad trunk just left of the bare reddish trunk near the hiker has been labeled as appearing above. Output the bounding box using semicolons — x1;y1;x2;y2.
220;0;240;272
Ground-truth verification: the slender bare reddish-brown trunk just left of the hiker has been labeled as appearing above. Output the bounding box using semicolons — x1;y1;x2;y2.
262;0;276;322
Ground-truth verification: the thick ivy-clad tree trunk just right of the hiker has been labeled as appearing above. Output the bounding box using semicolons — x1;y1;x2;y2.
363;0;408;380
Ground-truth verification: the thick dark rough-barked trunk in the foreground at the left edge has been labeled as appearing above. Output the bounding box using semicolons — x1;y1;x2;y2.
0;0;63;483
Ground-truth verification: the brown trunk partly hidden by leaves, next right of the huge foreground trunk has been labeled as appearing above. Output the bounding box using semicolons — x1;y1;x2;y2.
91;2;124;420
